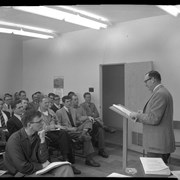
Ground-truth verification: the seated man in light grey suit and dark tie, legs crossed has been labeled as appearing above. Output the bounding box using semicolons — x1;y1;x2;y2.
56;96;100;167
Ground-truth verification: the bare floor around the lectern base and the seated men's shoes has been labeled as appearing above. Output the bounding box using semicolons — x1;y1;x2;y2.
71;131;180;177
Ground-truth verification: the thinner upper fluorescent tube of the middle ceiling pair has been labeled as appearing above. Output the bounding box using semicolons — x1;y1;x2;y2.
57;6;108;21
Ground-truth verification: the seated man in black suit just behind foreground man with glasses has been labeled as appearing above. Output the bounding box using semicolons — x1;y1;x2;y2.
7;99;24;136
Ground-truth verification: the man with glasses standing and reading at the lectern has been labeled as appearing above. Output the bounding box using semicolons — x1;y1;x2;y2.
130;71;175;164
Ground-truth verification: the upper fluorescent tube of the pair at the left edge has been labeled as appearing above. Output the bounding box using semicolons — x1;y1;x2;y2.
0;21;53;33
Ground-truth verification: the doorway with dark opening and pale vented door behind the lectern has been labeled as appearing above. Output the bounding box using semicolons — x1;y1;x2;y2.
100;62;152;152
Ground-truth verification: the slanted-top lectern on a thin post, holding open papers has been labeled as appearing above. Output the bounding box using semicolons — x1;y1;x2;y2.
109;104;134;170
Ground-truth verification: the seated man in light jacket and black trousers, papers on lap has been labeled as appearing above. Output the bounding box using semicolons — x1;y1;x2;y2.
38;96;81;174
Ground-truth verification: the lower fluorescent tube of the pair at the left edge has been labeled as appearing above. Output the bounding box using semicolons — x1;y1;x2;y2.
0;28;53;39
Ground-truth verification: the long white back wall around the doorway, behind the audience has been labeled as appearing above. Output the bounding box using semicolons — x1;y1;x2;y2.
23;15;180;119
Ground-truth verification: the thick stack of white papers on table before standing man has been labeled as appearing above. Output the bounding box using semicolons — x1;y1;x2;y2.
140;157;171;175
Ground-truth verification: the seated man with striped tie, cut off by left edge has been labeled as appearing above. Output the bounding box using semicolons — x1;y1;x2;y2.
0;98;9;152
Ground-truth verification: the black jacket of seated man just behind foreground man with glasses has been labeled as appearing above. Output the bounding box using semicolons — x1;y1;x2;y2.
7;115;23;136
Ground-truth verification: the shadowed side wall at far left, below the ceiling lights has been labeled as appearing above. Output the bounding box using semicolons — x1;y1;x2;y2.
0;34;23;97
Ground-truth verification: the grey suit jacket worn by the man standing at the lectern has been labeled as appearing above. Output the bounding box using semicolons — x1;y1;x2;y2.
138;85;175;154
